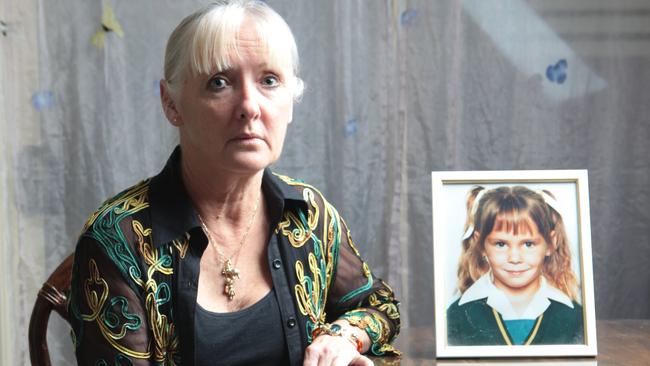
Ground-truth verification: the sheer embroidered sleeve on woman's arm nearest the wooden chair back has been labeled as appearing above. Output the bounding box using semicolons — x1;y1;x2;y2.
69;236;152;365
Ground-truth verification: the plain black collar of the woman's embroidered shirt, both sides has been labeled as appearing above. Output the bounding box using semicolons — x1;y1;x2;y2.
149;146;307;247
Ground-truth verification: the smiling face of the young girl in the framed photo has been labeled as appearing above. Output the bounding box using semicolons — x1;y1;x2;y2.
483;220;553;296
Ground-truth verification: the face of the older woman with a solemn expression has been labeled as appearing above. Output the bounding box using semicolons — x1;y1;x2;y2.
173;21;294;173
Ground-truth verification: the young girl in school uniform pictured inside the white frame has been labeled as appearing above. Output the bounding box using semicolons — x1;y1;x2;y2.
446;186;585;346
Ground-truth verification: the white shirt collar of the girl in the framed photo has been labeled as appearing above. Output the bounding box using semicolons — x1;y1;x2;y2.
458;272;573;320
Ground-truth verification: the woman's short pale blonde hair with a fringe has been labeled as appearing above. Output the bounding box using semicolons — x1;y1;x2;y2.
164;0;304;100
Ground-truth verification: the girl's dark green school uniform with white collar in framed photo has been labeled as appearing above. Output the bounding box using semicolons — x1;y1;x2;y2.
447;273;584;346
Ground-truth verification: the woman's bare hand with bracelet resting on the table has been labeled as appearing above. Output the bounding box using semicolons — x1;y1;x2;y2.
303;321;373;366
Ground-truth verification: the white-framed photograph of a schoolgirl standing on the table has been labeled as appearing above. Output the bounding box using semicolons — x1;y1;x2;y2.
432;170;597;358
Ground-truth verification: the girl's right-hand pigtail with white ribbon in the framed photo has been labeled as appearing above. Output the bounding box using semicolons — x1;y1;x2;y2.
542;190;578;300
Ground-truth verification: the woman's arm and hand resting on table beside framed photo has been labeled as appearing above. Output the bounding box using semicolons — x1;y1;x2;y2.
304;211;400;366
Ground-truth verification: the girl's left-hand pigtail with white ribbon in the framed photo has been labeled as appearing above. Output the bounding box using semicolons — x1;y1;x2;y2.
458;186;489;294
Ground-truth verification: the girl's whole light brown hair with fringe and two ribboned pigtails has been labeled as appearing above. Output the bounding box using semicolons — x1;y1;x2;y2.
458;186;578;300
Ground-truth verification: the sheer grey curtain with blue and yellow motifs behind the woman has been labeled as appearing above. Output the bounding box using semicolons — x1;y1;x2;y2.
0;0;650;365
